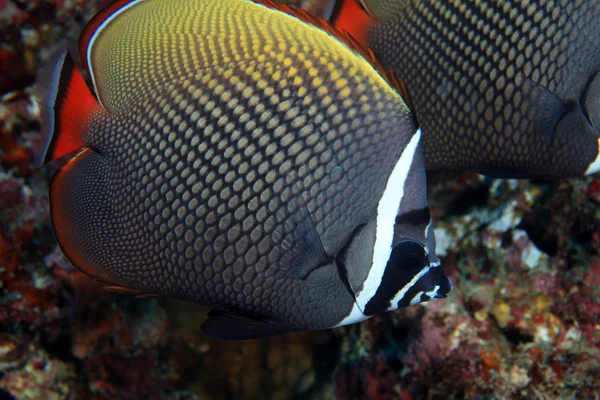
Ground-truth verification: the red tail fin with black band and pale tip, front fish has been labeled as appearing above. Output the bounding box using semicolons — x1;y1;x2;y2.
36;47;101;166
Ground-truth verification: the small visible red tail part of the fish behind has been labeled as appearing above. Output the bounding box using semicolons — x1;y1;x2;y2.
330;0;373;47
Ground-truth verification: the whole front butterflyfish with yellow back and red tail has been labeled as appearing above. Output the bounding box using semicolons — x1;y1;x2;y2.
40;0;452;339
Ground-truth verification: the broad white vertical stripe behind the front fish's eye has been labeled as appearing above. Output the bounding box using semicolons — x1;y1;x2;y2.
356;129;421;312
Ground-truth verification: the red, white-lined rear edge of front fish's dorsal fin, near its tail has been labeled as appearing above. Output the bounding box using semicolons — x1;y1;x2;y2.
78;0;144;106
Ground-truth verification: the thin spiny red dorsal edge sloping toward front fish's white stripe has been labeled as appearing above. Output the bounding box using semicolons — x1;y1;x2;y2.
252;0;418;118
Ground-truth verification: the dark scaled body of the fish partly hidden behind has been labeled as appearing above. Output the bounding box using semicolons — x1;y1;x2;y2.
370;0;600;176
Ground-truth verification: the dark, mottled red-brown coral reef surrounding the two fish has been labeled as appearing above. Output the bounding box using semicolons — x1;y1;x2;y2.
0;0;600;400
